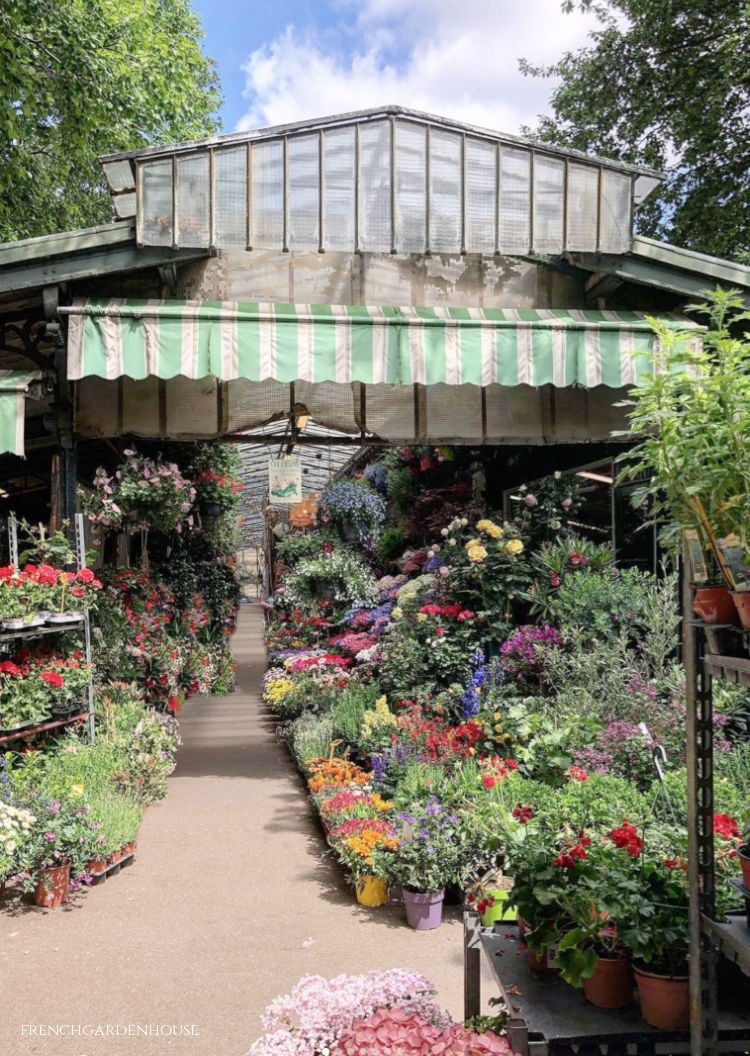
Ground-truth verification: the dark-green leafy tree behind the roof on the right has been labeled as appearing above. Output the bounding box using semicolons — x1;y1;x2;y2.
522;0;750;261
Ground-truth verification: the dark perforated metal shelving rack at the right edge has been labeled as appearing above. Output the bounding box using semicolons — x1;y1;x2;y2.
682;582;750;1056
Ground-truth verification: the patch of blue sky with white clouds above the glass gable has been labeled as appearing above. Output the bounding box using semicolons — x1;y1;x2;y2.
238;0;596;133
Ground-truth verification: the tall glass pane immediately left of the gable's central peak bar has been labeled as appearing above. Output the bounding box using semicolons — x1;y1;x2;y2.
359;121;391;252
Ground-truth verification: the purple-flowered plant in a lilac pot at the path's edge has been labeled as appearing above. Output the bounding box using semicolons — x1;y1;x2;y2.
391;796;465;931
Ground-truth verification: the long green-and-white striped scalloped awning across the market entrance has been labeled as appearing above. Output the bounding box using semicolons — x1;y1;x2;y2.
63;300;696;389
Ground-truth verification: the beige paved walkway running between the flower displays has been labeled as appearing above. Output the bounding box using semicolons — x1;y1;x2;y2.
0;604;481;1056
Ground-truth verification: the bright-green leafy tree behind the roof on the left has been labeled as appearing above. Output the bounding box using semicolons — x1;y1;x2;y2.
0;0;221;242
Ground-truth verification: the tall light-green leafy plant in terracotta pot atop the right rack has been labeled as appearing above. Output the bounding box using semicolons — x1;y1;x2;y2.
620;289;750;626
